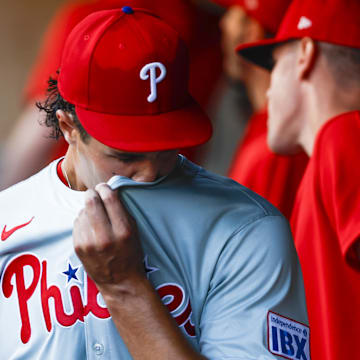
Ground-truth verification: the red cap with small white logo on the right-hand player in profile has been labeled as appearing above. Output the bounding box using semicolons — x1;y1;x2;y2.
236;0;360;70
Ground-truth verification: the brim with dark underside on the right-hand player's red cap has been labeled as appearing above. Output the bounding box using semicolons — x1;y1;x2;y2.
236;38;286;71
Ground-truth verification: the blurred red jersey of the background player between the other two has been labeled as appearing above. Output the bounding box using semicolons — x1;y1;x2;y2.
229;111;308;219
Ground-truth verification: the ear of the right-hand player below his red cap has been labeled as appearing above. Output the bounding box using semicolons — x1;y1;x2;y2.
297;37;317;80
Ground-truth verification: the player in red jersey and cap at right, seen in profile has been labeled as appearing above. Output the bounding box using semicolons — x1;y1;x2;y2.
239;0;360;360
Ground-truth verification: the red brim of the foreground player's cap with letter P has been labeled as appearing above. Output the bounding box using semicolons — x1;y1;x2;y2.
75;101;212;152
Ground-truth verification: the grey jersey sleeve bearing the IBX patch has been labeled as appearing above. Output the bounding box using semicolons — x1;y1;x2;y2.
200;216;310;360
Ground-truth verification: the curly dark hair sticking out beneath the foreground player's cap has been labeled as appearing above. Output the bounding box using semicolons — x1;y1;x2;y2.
36;77;91;143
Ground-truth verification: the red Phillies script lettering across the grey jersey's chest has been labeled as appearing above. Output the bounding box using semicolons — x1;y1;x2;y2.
2;254;195;344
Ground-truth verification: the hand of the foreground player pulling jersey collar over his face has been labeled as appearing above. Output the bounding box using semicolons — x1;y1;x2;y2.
73;184;145;287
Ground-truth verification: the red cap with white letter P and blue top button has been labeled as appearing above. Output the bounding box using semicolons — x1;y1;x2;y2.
58;6;212;152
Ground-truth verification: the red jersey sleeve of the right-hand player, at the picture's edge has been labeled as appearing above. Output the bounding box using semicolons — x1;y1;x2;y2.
319;113;360;270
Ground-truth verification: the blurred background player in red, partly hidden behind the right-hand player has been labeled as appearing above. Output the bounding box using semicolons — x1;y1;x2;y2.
211;0;308;219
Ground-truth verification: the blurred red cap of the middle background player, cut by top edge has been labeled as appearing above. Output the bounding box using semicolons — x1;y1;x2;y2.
214;0;291;34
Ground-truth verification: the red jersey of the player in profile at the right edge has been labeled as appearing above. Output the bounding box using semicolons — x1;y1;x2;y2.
292;112;360;360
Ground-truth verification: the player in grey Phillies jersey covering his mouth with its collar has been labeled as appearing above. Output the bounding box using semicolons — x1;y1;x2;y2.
0;6;310;360
